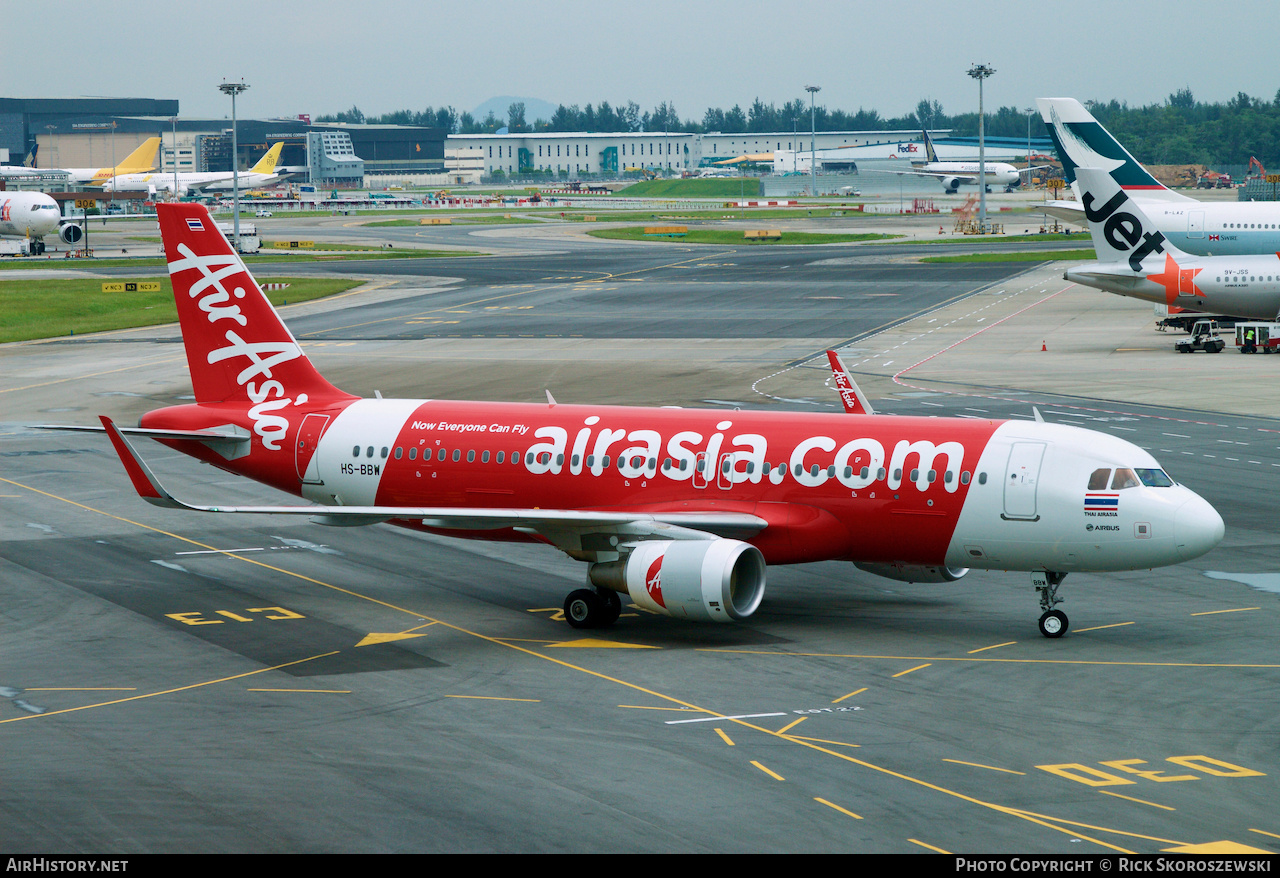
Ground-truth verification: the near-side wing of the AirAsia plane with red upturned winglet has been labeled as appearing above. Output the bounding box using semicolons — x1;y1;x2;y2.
99;416;768;542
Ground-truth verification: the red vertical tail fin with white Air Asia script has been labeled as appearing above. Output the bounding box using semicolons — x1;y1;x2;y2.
156;204;355;410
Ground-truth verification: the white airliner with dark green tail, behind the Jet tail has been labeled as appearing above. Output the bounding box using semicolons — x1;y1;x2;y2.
1036;97;1280;258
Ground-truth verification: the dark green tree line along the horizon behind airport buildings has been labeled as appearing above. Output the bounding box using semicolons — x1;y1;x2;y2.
316;87;1280;166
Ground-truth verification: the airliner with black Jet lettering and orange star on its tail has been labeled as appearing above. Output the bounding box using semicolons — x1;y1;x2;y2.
1062;168;1280;320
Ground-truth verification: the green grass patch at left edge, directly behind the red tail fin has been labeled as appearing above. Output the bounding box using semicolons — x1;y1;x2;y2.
0;278;364;342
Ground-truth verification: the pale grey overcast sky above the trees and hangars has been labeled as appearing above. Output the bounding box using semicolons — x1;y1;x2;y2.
12;0;1280;122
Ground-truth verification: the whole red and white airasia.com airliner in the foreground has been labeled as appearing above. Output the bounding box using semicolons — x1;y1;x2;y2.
81;204;1222;637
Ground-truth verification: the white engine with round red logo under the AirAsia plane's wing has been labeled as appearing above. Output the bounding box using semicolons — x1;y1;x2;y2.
589;539;765;622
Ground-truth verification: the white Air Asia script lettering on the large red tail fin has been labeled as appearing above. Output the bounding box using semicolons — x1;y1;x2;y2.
169;243;307;451
